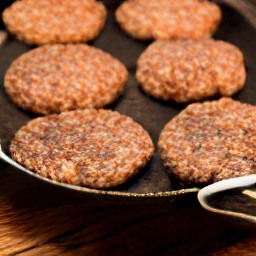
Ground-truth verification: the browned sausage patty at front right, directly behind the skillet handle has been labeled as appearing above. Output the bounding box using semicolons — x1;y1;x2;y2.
158;98;256;184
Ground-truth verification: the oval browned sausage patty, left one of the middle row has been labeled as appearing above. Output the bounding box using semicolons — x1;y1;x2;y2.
4;44;128;114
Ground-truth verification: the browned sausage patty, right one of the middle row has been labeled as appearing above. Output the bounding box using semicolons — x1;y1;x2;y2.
136;39;246;102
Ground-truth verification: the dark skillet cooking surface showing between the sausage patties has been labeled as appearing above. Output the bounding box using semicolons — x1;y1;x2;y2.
0;1;256;196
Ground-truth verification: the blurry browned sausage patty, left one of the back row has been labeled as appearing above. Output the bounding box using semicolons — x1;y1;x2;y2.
3;0;106;45
